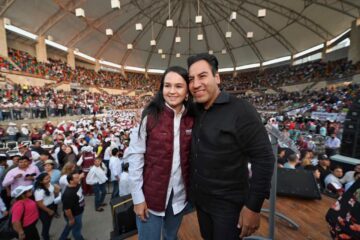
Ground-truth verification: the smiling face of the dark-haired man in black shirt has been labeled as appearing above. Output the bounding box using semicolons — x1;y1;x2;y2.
189;60;220;108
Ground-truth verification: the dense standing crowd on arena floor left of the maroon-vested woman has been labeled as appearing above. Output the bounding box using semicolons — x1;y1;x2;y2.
0;110;138;240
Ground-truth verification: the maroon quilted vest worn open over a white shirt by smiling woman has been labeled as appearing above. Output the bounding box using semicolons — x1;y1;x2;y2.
143;107;193;212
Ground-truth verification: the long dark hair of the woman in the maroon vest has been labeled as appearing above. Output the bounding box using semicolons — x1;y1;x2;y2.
139;66;193;136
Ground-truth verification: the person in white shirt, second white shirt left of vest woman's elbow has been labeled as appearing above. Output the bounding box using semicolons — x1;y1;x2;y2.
109;148;122;198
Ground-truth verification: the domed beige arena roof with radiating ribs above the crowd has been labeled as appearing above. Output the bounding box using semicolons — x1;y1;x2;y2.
0;0;360;69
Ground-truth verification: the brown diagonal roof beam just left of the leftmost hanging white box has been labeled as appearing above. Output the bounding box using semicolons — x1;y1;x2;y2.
35;0;86;36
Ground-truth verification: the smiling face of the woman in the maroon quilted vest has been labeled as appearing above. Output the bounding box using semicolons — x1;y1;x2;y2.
162;72;188;110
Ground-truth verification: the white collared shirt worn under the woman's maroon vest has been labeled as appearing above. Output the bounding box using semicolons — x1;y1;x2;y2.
124;105;187;216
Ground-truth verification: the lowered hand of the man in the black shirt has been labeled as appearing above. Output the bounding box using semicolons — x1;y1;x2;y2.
237;206;260;238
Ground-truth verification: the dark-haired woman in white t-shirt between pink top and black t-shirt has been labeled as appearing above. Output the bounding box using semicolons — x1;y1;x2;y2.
34;172;60;240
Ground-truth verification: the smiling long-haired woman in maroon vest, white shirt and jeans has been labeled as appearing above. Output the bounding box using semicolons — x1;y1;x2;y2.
125;66;193;240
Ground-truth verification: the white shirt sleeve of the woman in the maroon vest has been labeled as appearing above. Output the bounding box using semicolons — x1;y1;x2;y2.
124;117;147;204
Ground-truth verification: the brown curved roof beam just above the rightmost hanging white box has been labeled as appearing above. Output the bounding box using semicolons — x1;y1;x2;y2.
242;0;334;41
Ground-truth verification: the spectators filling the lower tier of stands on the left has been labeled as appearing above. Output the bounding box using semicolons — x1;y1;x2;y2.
0;84;150;121
